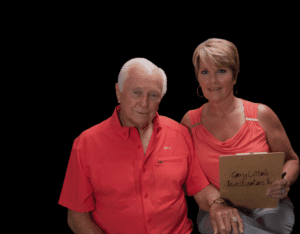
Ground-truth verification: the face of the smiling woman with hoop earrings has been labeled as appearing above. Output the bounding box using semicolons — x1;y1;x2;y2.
198;60;236;102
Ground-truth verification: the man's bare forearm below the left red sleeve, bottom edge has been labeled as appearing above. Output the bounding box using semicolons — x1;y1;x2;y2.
68;209;104;234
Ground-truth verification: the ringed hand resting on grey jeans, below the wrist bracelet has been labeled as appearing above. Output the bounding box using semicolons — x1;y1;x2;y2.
209;204;244;234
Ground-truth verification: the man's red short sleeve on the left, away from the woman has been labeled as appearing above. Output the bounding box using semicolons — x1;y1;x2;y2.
58;138;95;212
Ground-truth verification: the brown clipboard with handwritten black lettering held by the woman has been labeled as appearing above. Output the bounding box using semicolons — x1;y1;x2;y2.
219;152;285;209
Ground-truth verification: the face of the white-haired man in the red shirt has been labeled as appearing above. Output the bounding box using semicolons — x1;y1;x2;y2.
116;67;163;129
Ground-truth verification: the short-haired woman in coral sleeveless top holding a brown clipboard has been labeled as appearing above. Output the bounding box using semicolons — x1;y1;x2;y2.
181;39;299;234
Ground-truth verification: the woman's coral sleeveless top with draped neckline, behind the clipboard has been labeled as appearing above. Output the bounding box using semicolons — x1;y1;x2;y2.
189;100;270;189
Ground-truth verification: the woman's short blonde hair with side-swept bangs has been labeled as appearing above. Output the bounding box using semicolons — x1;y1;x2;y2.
193;38;240;80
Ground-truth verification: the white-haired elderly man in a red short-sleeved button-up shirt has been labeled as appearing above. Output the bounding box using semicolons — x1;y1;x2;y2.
59;58;241;234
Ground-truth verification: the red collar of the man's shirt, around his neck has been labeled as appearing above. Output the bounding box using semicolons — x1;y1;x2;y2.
111;105;162;140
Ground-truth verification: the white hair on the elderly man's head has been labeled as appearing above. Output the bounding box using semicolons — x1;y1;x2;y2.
118;58;167;96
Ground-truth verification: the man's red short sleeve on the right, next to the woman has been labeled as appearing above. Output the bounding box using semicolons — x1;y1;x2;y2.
184;131;210;196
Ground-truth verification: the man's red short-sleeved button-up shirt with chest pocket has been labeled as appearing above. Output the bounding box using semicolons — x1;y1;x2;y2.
59;106;209;234
